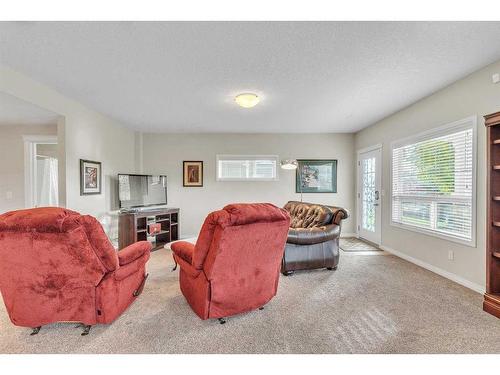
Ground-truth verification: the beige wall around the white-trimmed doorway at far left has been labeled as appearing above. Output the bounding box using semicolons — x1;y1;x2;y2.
0;124;57;213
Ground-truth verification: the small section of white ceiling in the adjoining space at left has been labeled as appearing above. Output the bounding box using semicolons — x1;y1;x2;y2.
0;92;58;126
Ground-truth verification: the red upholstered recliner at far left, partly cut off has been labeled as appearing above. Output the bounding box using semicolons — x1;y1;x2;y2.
0;207;151;335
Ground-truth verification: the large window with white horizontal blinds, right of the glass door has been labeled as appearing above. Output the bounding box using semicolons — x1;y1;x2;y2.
392;117;476;246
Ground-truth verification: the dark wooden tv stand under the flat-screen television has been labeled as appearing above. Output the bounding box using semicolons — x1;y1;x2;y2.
118;207;180;251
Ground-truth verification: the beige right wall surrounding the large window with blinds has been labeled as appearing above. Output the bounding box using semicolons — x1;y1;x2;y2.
355;62;500;290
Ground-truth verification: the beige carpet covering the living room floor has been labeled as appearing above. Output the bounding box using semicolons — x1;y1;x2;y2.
0;250;500;353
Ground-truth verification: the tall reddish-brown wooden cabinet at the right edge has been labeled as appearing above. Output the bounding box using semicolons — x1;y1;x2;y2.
483;112;500;318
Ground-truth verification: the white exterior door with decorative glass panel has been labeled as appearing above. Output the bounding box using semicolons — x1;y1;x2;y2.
357;147;382;245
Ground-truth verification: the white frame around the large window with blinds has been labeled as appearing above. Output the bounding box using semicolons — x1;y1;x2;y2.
389;115;477;247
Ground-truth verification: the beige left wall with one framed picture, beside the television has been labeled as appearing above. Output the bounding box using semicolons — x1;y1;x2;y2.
0;67;136;217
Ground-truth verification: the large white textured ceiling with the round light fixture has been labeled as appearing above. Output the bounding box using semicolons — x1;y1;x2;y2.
0;22;500;132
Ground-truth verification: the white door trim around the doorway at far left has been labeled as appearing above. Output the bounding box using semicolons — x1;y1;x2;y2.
23;135;57;208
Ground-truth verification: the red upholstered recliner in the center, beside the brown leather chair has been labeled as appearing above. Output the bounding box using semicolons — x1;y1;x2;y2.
171;203;290;323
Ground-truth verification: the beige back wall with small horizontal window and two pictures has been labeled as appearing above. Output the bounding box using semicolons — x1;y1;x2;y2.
142;134;354;236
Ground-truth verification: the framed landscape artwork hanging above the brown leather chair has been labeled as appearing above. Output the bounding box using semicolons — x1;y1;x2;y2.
295;160;337;193
